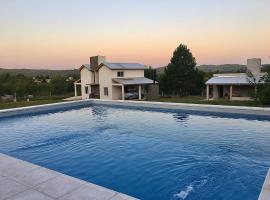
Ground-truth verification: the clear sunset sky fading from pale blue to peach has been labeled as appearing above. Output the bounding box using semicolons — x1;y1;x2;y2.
0;0;270;69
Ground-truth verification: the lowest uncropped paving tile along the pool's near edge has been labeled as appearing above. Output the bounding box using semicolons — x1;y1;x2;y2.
36;175;85;198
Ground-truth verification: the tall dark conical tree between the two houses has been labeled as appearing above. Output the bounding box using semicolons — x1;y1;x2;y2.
161;44;203;96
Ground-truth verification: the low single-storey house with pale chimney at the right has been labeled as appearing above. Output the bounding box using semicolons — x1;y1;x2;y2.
206;58;265;100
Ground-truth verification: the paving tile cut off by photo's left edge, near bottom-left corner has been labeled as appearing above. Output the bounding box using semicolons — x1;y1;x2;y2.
0;178;28;200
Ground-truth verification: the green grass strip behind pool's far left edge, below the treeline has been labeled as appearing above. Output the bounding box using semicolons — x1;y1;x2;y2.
0;99;63;110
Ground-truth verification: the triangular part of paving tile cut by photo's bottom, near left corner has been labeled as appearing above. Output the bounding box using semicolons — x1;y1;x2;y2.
7;189;53;200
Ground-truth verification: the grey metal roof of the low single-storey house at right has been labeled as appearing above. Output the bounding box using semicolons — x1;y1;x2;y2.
206;74;263;85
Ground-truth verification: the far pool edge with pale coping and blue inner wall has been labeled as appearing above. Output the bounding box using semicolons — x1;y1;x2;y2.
0;99;270;118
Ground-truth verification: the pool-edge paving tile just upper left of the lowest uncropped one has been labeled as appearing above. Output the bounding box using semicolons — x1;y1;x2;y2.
11;167;61;187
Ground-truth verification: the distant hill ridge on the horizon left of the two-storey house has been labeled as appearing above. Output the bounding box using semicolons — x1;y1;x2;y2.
0;68;80;77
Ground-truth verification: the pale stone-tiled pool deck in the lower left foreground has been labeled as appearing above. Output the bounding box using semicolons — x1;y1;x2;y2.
0;153;136;200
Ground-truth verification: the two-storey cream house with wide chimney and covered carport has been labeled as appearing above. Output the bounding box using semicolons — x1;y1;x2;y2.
74;56;158;100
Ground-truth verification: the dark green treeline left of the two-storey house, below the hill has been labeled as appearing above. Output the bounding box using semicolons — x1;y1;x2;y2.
0;74;74;98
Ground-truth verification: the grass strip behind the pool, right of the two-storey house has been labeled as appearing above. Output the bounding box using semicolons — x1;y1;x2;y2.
153;96;263;107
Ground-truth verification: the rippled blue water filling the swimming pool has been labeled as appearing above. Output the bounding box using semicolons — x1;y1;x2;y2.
0;105;270;200
